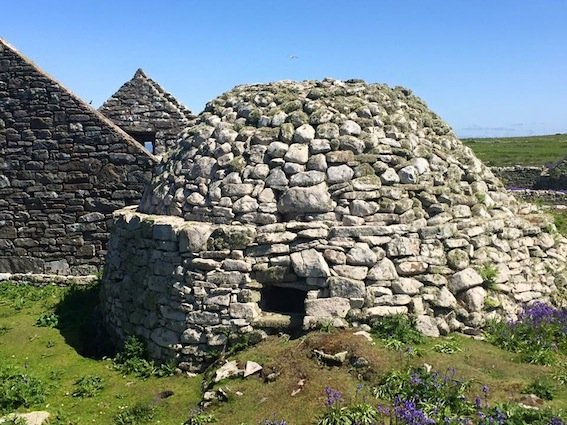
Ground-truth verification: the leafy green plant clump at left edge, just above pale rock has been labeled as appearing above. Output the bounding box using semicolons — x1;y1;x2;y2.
0;366;46;412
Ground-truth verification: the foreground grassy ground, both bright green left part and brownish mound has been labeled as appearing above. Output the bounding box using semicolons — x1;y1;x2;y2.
0;284;567;425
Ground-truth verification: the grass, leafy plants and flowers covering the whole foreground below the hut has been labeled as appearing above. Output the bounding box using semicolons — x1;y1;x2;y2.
0;284;567;425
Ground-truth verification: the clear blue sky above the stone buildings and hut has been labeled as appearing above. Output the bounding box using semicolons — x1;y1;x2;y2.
4;0;567;137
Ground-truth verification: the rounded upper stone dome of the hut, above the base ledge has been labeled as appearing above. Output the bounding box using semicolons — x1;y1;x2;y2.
140;79;513;225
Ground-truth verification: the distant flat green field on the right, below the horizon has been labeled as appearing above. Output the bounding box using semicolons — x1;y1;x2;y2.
462;134;567;167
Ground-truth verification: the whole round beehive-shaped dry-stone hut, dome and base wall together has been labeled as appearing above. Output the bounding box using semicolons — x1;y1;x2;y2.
103;80;566;369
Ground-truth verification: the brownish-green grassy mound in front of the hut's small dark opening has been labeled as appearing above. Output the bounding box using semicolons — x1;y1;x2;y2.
211;331;567;425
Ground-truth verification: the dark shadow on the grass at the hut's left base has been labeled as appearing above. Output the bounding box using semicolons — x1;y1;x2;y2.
55;285;115;359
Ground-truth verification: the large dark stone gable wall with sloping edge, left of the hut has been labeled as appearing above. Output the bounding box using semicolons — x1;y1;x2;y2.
0;40;157;275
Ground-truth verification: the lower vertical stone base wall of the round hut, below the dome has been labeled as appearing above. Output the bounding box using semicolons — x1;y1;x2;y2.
101;208;567;370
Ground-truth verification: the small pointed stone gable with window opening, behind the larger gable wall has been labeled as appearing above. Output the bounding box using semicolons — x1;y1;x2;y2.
99;69;195;155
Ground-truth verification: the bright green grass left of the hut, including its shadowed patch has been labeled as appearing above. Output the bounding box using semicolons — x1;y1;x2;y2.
0;283;201;425
